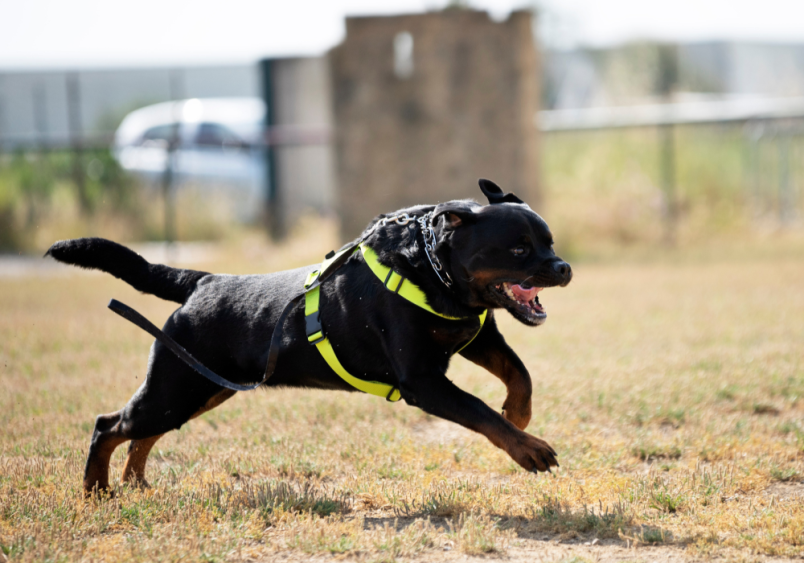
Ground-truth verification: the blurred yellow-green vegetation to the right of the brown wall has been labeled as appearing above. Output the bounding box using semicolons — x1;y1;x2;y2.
540;125;804;258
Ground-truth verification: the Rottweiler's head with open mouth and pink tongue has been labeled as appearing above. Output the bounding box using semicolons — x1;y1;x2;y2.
434;180;572;326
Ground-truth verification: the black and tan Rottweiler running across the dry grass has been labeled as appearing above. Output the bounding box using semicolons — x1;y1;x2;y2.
47;180;572;493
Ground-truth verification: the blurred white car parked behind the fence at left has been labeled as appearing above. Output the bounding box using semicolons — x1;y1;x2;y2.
114;98;266;220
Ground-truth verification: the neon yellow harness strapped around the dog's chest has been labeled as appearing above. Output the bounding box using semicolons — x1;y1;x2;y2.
304;243;488;402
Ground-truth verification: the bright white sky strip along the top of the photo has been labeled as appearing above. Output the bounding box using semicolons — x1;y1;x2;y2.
0;0;804;69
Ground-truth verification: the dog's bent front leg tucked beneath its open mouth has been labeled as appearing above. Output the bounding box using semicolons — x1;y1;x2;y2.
461;317;533;430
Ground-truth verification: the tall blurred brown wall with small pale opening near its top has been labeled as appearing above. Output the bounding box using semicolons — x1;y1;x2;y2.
330;10;539;237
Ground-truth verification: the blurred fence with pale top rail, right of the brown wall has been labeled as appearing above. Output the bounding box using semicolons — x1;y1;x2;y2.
539;99;804;251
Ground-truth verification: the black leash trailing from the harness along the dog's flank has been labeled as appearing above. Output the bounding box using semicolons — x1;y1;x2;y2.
109;293;304;391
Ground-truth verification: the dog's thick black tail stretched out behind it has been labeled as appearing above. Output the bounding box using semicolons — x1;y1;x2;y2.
45;238;209;303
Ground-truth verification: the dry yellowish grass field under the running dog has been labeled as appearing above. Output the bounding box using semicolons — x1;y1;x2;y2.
0;227;804;561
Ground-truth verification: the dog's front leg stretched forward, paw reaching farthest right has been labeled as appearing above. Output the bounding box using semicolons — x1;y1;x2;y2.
399;373;558;472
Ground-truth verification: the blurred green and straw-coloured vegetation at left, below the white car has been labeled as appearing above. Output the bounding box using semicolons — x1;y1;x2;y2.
0;149;237;253
